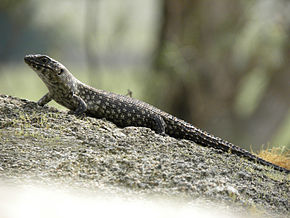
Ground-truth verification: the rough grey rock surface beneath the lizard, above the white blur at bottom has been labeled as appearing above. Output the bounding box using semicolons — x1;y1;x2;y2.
0;95;290;217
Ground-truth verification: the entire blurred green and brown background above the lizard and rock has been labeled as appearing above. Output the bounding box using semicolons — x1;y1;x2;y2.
0;0;290;151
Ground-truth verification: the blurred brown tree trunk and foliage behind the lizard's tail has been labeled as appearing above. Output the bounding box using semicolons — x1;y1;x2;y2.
148;0;290;150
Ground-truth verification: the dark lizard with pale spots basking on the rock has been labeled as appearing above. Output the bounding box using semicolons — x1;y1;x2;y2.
24;54;289;174
